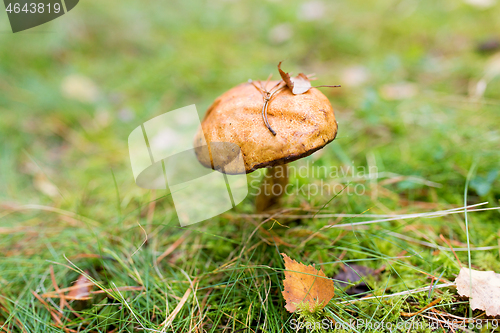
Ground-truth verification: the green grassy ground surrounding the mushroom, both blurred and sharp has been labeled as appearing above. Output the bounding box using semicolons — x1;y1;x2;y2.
0;0;500;332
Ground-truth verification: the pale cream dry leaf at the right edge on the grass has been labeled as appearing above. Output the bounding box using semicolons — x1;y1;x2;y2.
455;267;500;316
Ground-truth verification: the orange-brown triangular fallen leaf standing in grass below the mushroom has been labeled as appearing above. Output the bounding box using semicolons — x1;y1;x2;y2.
281;253;335;312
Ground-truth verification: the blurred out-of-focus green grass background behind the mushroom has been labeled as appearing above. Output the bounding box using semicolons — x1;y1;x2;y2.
0;0;500;202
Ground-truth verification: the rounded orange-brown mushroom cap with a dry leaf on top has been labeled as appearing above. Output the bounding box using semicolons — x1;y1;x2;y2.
194;81;337;174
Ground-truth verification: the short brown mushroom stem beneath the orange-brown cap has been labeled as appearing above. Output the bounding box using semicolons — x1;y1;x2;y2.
255;164;288;213
